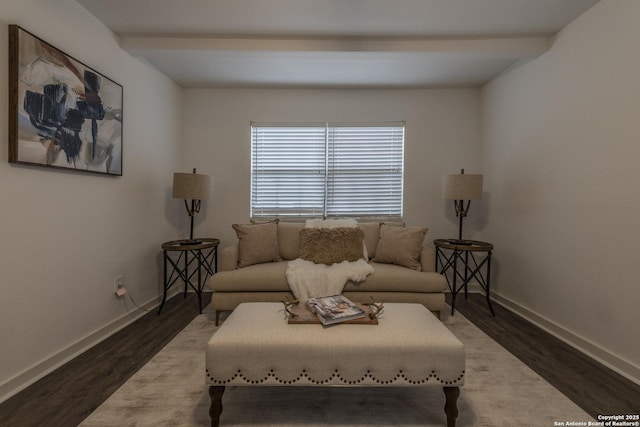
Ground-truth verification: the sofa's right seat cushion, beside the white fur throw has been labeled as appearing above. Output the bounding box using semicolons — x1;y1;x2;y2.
344;262;447;293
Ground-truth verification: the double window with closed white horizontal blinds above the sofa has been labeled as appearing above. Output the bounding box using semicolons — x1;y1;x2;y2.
251;123;404;219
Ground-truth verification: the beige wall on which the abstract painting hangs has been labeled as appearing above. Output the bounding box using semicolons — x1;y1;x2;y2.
0;0;186;401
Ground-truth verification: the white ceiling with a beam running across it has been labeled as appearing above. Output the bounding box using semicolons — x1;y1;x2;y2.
77;0;598;87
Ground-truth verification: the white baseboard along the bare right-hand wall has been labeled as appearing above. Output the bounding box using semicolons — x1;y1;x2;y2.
490;287;640;384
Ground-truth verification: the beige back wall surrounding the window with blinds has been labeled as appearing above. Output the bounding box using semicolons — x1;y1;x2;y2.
184;89;481;244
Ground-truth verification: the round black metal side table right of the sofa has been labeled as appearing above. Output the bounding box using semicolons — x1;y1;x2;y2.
433;239;496;316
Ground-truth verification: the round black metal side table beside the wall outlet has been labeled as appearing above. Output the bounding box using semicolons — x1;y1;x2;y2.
158;238;220;314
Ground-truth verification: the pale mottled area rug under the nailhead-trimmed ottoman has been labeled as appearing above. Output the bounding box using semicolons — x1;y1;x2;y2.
81;310;593;427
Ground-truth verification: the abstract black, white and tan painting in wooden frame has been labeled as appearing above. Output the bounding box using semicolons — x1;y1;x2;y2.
9;25;122;175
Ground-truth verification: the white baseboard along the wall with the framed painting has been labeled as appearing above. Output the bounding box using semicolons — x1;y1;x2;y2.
0;289;180;403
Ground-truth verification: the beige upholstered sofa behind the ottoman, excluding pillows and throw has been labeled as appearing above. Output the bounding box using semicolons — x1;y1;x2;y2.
209;222;447;324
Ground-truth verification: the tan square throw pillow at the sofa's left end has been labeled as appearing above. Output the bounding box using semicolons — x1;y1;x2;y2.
232;219;282;267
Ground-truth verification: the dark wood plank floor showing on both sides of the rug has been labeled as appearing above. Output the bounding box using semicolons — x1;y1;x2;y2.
0;294;640;427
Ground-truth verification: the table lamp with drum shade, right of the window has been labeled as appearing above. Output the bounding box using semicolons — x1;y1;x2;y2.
442;169;482;244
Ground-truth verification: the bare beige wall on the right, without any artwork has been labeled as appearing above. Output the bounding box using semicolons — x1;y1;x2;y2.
482;0;640;381
